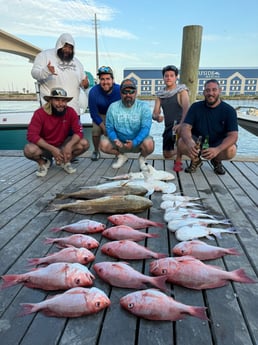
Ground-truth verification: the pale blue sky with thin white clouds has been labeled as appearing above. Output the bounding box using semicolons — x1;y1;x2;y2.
0;0;258;92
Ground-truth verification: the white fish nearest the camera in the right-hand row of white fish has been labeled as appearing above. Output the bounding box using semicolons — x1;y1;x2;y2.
175;225;237;241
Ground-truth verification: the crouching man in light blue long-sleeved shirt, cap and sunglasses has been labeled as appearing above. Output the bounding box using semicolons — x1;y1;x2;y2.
100;79;154;170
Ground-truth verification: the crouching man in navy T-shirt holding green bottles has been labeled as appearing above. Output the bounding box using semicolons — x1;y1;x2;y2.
178;79;238;175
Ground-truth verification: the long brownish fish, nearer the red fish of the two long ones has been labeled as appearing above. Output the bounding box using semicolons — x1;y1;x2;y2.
49;195;152;214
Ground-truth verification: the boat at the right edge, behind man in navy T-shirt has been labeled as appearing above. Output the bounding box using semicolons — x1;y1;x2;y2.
236;106;258;136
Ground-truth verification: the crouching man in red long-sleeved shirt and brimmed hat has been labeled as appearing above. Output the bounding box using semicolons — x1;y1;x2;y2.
24;88;90;177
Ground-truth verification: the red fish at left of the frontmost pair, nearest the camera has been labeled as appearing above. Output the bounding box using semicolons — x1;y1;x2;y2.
20;287;110;317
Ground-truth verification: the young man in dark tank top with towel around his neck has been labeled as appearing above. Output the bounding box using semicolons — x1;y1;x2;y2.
152;65;189;172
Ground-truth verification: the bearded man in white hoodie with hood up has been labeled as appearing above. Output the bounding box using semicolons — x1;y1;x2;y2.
31;33;89;115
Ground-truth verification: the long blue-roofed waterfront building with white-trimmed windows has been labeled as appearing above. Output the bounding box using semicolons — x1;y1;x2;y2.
124;67;258;96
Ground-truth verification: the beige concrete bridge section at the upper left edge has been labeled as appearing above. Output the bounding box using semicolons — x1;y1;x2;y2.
0;30;41;62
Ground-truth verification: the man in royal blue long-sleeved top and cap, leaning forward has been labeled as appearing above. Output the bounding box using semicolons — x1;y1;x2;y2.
89;66;121;161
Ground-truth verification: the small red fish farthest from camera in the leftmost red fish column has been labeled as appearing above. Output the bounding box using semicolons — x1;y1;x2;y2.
51;219;106;234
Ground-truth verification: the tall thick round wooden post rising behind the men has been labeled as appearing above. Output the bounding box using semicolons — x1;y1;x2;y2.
180;25;202;104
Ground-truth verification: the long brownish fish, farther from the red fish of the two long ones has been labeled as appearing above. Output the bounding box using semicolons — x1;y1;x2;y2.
56;181;148;199
